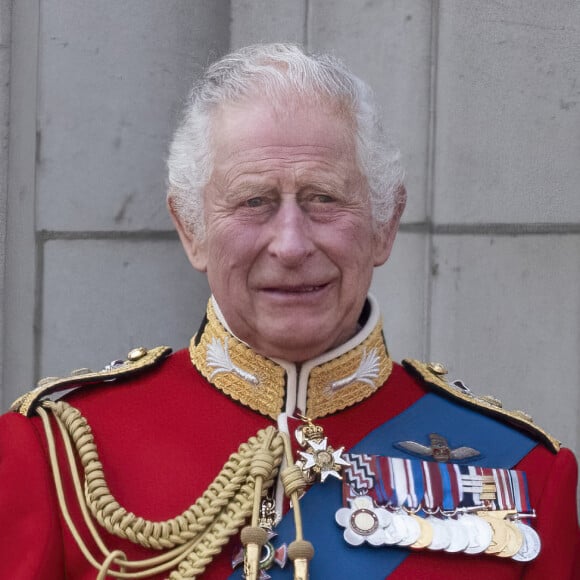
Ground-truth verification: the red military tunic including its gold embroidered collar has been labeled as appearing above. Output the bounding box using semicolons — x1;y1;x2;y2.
0;296;580;580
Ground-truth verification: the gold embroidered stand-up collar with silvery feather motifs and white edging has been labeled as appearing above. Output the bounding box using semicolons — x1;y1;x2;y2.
189;296;393;420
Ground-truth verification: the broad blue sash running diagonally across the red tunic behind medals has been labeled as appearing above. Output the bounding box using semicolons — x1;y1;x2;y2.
230;393;536;580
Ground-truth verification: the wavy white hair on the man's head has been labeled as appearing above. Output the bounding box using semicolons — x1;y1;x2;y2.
167;43;405;237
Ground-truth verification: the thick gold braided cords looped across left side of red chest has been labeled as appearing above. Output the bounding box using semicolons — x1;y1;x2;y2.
38;401;284;580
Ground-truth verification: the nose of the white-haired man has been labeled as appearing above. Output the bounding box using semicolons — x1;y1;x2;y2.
268;197;315;267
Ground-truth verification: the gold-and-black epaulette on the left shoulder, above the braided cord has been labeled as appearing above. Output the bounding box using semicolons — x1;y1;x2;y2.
10;346;171;417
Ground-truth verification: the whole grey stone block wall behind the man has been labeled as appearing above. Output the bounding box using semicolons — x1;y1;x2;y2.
0;0;580;466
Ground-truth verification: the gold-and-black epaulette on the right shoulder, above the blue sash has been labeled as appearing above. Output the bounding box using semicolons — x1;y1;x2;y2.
403;359;561;453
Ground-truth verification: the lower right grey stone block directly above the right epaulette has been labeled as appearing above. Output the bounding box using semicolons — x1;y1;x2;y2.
430;235;580;451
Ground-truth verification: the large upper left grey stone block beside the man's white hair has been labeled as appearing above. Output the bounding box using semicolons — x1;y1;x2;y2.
37;0;229;231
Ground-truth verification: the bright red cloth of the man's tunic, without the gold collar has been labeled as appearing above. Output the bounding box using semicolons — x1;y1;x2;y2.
0;351;580;580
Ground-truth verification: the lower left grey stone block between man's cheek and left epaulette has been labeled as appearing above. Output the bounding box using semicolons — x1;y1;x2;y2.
40;239;209;376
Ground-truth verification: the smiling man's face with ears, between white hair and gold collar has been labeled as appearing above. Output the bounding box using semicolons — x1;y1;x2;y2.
174;99;394;362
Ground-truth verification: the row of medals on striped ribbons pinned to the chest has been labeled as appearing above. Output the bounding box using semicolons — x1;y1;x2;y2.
335;454;541;562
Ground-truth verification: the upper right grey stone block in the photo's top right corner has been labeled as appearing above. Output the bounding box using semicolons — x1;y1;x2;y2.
434;0;580;223
